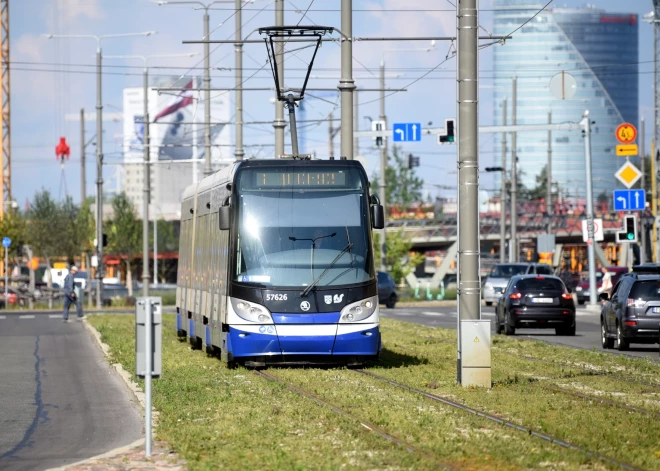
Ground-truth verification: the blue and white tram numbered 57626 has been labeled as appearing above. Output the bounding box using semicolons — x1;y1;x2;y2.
176;159;383;366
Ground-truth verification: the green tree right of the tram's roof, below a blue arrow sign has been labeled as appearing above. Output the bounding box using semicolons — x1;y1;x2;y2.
372;146;424;211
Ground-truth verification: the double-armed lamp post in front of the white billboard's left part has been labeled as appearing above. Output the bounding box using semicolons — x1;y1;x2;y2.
106;53;197;297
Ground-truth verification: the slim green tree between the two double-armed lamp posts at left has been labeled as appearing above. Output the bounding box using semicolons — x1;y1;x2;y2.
107;193;142;296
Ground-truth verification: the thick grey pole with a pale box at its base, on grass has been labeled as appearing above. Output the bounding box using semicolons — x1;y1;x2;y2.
456;0;491;387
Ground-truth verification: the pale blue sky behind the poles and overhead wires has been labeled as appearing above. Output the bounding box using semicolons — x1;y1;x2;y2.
10;0;653;206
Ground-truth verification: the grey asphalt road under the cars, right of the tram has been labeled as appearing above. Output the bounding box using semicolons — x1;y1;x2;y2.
380;306;660;362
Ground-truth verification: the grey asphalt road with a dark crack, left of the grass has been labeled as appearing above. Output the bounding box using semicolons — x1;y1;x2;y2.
0;311;142;471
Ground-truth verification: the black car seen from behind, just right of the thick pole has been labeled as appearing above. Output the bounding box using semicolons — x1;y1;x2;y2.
495;275;575;335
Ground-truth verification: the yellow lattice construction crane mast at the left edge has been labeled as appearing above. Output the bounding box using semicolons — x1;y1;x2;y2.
0;0;12;218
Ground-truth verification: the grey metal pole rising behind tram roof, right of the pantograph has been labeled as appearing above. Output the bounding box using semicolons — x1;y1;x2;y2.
339;0;355;160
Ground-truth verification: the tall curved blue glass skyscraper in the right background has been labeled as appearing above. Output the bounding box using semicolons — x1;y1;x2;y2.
494;0;639;204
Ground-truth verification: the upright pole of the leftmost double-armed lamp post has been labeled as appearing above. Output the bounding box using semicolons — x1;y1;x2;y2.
96;45;103;309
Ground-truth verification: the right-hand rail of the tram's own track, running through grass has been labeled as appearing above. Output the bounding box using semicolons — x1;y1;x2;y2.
352;369;642;471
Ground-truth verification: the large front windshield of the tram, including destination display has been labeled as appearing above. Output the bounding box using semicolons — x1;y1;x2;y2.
234;165;374;289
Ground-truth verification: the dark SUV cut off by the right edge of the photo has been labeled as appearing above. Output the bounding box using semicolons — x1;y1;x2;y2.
598;265;660;350
